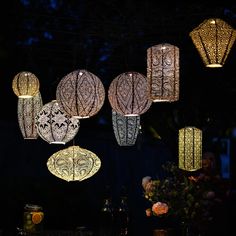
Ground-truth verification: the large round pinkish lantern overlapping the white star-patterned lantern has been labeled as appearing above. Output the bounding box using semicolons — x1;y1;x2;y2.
56;70;105;119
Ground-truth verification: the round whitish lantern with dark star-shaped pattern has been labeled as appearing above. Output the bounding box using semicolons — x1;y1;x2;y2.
36;100;80;144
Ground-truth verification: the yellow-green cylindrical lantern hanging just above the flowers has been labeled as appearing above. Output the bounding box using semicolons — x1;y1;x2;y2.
179;127;202;171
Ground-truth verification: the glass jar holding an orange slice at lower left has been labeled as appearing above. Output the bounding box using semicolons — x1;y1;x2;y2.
23;204;44;234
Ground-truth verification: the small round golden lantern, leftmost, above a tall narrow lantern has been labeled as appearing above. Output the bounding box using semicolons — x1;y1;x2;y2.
12;71;39;98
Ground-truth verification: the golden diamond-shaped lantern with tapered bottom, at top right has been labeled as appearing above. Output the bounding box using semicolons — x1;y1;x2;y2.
190;18;236;67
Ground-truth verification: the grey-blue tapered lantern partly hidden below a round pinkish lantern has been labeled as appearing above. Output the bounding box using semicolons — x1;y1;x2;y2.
112;110;140;146
